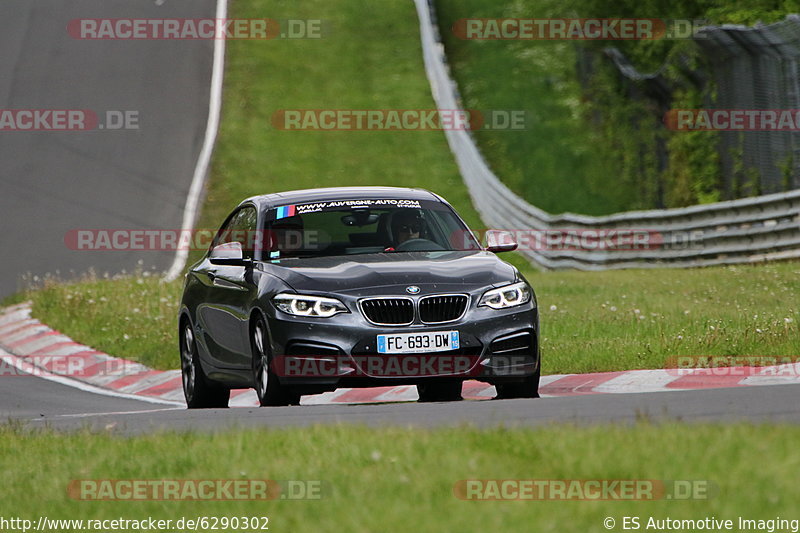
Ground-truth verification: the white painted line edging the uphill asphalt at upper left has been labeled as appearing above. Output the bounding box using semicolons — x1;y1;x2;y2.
164;0;228;281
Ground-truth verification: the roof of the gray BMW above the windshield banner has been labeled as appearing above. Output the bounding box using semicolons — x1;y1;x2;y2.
242;187;443;208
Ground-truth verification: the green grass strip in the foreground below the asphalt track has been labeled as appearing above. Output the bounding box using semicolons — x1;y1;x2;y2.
0;424;800;533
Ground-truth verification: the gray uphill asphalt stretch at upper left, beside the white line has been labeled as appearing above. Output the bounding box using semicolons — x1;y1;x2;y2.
0;0;216;298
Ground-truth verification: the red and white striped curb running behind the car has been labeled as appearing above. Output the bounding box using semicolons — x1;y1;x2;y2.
0;303;800;407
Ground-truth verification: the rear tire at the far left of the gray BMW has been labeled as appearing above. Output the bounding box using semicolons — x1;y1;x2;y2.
180;320;231;409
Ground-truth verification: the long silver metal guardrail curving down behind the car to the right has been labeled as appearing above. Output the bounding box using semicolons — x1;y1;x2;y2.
415;0;800;270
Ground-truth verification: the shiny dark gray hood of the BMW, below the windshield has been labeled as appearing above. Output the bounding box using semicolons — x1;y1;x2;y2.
265;251;517;296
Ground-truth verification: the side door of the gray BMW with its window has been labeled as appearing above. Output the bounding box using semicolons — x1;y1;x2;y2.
197;206;257;369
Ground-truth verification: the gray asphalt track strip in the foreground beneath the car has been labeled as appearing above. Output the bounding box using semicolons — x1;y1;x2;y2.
0;362;800;434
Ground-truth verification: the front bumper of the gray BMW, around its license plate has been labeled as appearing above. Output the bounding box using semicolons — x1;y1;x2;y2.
268;303;540;391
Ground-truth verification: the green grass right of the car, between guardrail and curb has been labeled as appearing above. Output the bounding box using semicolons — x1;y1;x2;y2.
529;262;800;374
